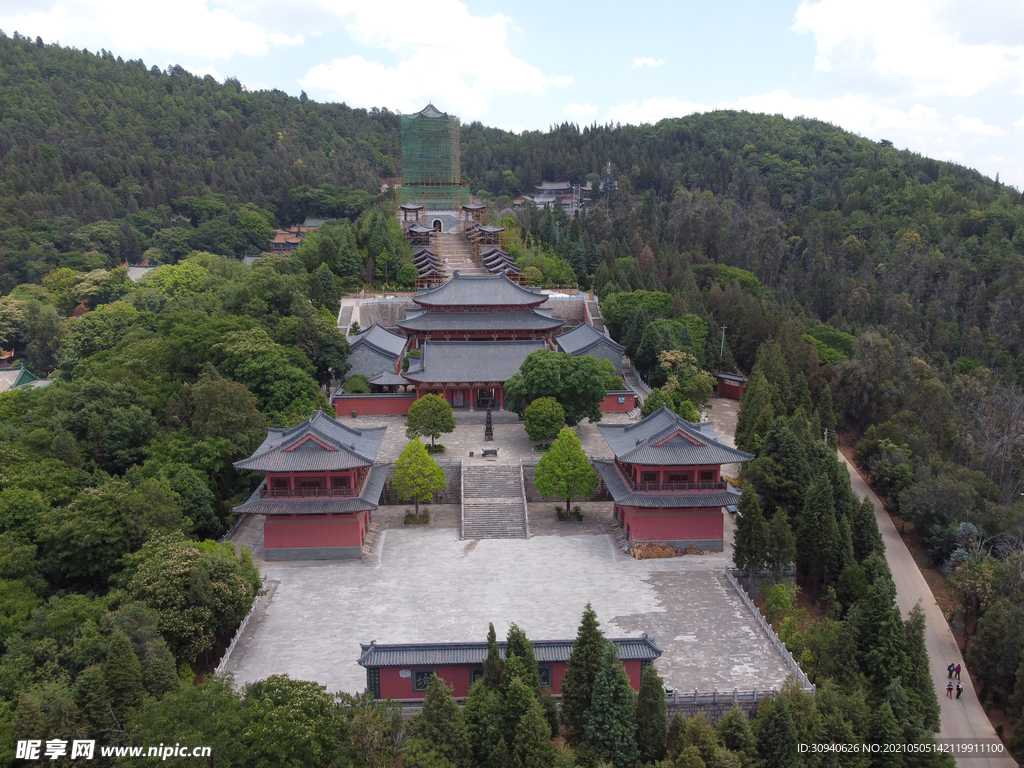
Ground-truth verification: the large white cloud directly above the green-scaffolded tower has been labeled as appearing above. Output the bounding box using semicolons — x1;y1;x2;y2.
299;0;572;120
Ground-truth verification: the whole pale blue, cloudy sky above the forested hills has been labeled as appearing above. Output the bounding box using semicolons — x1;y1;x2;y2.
0;0;1024;188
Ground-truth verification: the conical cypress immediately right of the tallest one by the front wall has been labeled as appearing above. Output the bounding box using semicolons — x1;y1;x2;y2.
584;643;640;768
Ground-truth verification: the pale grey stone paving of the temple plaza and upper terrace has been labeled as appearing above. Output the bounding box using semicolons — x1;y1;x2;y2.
227;400;788;693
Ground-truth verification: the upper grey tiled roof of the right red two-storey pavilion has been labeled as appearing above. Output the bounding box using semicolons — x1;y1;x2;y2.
597;406;754;466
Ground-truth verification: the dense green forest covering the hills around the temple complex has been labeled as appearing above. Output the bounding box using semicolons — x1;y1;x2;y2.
0;33;1024;766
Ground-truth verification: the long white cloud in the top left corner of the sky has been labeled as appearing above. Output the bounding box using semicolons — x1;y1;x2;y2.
0;0;302;58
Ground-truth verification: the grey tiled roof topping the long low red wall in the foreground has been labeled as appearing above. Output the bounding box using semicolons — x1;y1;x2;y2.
358;635;663;668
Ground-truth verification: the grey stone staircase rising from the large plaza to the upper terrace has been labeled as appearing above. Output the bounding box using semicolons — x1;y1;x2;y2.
462;464;529;539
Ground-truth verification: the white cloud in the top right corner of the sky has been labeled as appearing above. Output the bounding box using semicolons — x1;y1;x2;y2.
793;0;1024;97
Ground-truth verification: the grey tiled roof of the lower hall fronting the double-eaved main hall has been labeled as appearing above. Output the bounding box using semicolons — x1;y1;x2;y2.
402;341;547;384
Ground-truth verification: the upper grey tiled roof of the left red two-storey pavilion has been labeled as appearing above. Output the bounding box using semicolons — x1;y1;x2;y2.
234;411;387;472
